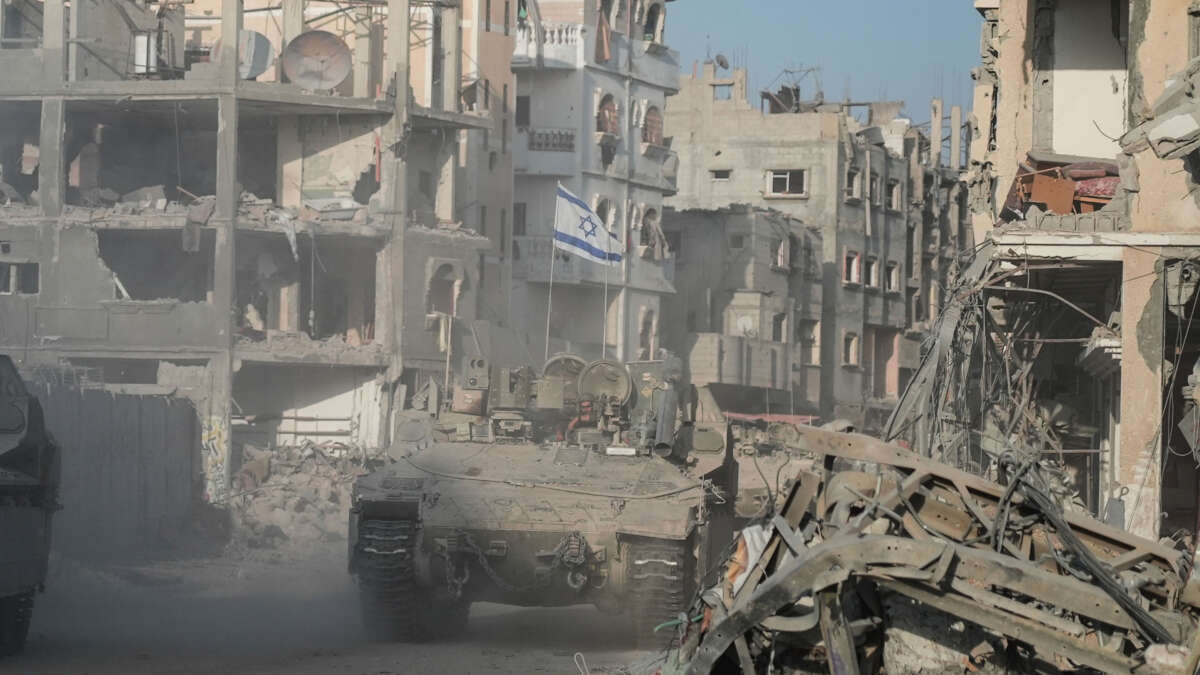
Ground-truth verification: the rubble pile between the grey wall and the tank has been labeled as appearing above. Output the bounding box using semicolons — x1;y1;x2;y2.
232;442;362;549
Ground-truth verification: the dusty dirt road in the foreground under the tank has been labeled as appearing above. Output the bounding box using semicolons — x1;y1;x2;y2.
7;551;647;675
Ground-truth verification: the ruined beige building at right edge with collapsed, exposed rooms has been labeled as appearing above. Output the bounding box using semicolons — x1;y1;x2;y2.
893;0;1200;537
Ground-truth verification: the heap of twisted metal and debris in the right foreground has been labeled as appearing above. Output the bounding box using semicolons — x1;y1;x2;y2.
661;426;1200;675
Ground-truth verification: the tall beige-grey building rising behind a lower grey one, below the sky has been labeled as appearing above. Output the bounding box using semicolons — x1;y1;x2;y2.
666;62;961;431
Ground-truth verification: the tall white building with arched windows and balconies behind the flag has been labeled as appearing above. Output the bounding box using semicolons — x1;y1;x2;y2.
502;0;679;359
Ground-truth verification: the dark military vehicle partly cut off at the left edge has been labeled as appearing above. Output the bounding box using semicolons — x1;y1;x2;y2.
0;354;59;656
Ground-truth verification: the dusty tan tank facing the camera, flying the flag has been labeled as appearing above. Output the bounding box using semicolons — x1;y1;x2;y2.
349;354;737;646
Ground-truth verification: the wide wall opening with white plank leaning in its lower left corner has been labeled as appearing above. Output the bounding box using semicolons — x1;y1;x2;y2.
96;229;216;303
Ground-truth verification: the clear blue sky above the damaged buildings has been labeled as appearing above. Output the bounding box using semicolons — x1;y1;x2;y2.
666;0;980;124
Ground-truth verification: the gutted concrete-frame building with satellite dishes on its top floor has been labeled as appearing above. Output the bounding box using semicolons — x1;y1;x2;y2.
0;0;515;538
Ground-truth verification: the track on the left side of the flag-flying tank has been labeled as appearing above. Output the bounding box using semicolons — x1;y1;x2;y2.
355;520;470;643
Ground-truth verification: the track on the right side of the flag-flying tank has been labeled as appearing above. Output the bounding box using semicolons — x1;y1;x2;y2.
625;538;695;649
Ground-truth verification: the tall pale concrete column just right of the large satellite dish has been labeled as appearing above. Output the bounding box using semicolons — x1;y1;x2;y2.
376;0;409;369
